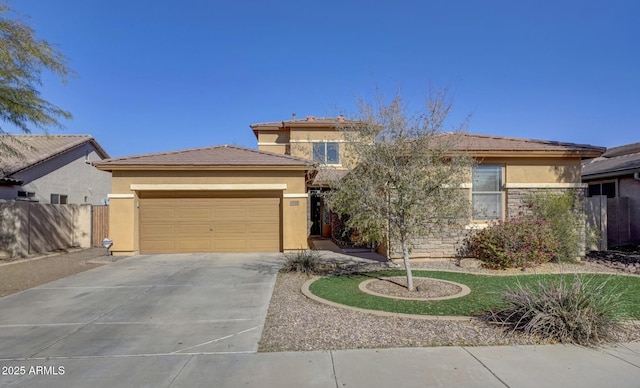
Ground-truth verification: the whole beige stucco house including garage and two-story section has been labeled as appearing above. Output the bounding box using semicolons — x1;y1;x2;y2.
97;116;604;257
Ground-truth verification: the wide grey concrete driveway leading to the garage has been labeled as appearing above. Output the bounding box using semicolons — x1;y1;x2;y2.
0;253;281;385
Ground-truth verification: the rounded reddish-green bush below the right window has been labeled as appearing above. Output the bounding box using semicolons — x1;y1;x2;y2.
462;217;559;269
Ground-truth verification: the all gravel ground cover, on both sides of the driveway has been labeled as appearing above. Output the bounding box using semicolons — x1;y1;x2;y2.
0;248;640;351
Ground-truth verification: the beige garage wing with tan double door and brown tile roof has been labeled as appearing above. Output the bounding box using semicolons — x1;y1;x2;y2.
97;145;308;255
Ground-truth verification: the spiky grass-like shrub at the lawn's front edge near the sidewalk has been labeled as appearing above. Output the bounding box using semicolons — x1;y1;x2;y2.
485;275;622;346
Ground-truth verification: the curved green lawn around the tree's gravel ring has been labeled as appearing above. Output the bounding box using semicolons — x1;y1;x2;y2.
309;270;640;319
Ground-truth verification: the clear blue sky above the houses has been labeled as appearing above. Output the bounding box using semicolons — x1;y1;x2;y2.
10;0;640;157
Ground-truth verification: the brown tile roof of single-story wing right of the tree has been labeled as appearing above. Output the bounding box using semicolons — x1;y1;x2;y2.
445;133;606;157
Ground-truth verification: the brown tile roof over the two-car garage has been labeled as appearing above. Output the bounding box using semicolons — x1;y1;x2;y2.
95;145;309;171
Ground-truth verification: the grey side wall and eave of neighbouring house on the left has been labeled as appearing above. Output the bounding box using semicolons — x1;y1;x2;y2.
0;144;111;205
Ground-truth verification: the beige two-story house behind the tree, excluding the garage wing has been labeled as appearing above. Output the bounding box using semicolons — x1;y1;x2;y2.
251;115;604;257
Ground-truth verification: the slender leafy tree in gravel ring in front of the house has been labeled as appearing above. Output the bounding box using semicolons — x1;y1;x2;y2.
324;90;474;290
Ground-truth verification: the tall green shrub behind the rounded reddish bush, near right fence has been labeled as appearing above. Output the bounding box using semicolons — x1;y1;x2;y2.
525;191;592;262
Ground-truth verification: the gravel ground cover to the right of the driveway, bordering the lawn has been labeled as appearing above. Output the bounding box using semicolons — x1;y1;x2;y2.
259;252;640;352
